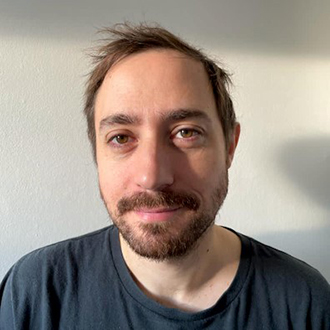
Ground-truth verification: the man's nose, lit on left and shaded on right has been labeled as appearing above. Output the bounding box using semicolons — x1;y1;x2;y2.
134;141;174;191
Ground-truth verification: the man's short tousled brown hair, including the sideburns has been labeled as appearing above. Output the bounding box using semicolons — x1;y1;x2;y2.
84;23;236;161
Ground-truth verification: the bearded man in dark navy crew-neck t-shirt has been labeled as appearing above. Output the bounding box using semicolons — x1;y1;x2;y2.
0;24;330;330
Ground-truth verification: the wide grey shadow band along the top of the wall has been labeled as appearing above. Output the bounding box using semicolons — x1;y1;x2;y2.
0;0;330;57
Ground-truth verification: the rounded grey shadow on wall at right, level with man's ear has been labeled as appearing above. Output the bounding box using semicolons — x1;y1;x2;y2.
279;135;330;211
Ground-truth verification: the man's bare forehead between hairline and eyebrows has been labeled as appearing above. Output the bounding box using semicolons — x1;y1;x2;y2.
95;50;216;123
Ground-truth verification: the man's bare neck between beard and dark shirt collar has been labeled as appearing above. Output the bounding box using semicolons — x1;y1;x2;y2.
120;225;240;312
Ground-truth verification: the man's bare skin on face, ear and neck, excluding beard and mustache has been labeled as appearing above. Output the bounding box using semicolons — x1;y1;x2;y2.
95;50;241;312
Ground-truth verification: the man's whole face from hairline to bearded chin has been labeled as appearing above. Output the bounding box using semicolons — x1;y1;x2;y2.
95;50;236;260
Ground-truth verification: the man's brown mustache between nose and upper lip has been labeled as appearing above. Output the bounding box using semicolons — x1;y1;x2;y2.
117;191;200;216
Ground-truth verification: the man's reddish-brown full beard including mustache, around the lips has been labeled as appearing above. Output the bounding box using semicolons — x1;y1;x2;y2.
100;170;228;261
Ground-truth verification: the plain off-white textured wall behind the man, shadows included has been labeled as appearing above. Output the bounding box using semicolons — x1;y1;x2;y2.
0;0;330;281
